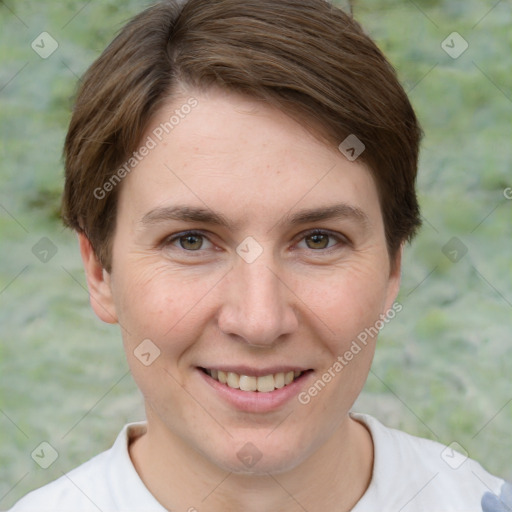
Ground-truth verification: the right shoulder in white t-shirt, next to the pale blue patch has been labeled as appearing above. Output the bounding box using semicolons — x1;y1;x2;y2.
351;413;504;512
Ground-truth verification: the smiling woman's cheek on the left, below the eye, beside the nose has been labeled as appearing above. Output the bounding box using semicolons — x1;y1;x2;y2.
111;257;215;404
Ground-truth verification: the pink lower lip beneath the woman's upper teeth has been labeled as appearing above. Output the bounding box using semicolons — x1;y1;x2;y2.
197;369;313;413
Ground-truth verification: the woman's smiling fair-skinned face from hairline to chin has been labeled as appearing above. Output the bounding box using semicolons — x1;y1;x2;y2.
86;90;399;473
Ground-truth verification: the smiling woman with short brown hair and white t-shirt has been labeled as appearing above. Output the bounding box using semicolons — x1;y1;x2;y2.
8;0;510;512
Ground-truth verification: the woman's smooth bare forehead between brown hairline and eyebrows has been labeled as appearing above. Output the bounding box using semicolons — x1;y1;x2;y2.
115;89;380;230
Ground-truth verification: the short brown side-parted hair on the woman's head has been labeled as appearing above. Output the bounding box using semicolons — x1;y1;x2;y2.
62;0;421;271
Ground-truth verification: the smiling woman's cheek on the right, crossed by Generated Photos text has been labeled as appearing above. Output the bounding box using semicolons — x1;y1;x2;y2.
299;265;387;416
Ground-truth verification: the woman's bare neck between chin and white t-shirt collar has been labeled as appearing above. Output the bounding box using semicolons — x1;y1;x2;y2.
130;416;373;512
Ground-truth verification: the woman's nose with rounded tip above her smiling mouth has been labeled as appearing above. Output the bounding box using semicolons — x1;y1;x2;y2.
218;255;298;347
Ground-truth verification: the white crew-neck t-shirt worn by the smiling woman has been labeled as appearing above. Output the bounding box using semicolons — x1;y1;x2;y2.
10;413;512;512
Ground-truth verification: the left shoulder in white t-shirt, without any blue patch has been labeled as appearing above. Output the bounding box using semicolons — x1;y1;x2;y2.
9;423;162;512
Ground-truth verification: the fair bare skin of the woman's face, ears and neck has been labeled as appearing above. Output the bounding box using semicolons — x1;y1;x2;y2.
80;89;401;512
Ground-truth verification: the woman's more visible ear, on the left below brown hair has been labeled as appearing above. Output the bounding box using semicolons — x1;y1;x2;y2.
78;233;117;324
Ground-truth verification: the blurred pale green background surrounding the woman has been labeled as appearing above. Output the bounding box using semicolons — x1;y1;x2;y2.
0;0;512;509
